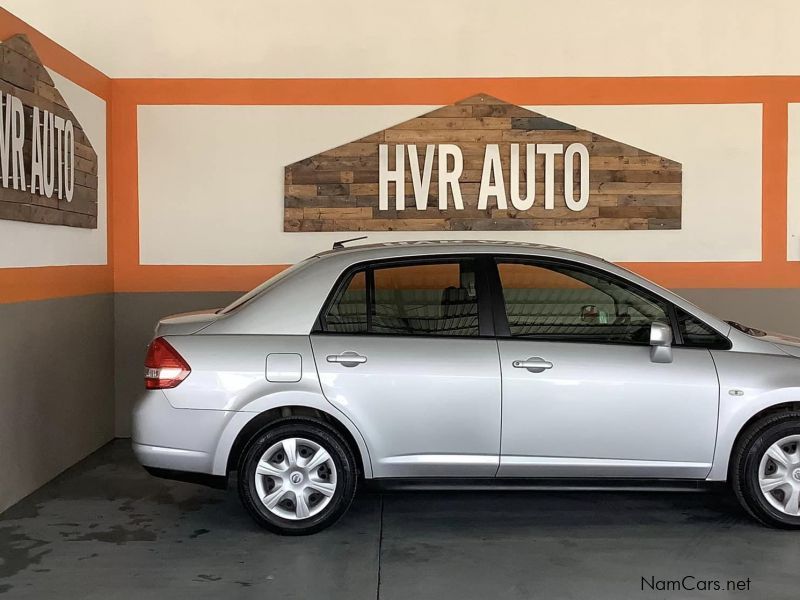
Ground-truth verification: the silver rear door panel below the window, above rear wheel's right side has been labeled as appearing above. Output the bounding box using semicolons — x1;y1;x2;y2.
311;334;501;477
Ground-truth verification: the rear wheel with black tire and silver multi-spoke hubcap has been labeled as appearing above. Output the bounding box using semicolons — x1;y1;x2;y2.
239;418;357;535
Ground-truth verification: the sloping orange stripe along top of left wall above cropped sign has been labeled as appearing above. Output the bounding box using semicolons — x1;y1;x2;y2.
0;8;111;100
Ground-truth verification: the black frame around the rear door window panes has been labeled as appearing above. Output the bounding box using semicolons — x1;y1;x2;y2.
311;253;496;340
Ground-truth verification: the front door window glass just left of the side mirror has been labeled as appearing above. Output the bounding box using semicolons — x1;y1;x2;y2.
497;261;670;344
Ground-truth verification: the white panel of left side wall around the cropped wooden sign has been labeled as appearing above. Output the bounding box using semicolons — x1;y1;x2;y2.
0;69;107;268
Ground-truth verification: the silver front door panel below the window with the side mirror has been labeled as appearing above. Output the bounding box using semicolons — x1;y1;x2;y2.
498;339;719;477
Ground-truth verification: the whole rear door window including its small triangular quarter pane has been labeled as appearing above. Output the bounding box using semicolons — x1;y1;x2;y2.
323;259;479;336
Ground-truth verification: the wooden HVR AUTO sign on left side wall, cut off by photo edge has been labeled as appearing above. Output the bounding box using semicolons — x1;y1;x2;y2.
0;34;97;229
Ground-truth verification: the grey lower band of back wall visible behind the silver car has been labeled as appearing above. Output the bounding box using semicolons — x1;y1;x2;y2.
114;289;800;437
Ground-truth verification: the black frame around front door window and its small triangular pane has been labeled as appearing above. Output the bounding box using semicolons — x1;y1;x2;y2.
487;254;732;350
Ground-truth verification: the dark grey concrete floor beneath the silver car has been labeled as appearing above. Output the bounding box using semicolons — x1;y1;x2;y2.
0;441;800;600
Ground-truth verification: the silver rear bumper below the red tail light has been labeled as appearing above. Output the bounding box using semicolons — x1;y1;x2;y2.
131;390;235;478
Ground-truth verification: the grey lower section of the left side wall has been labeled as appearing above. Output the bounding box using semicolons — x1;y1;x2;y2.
0;294;114;512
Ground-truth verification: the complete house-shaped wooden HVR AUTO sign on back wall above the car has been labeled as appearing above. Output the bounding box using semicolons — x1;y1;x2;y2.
284;94;681;231
